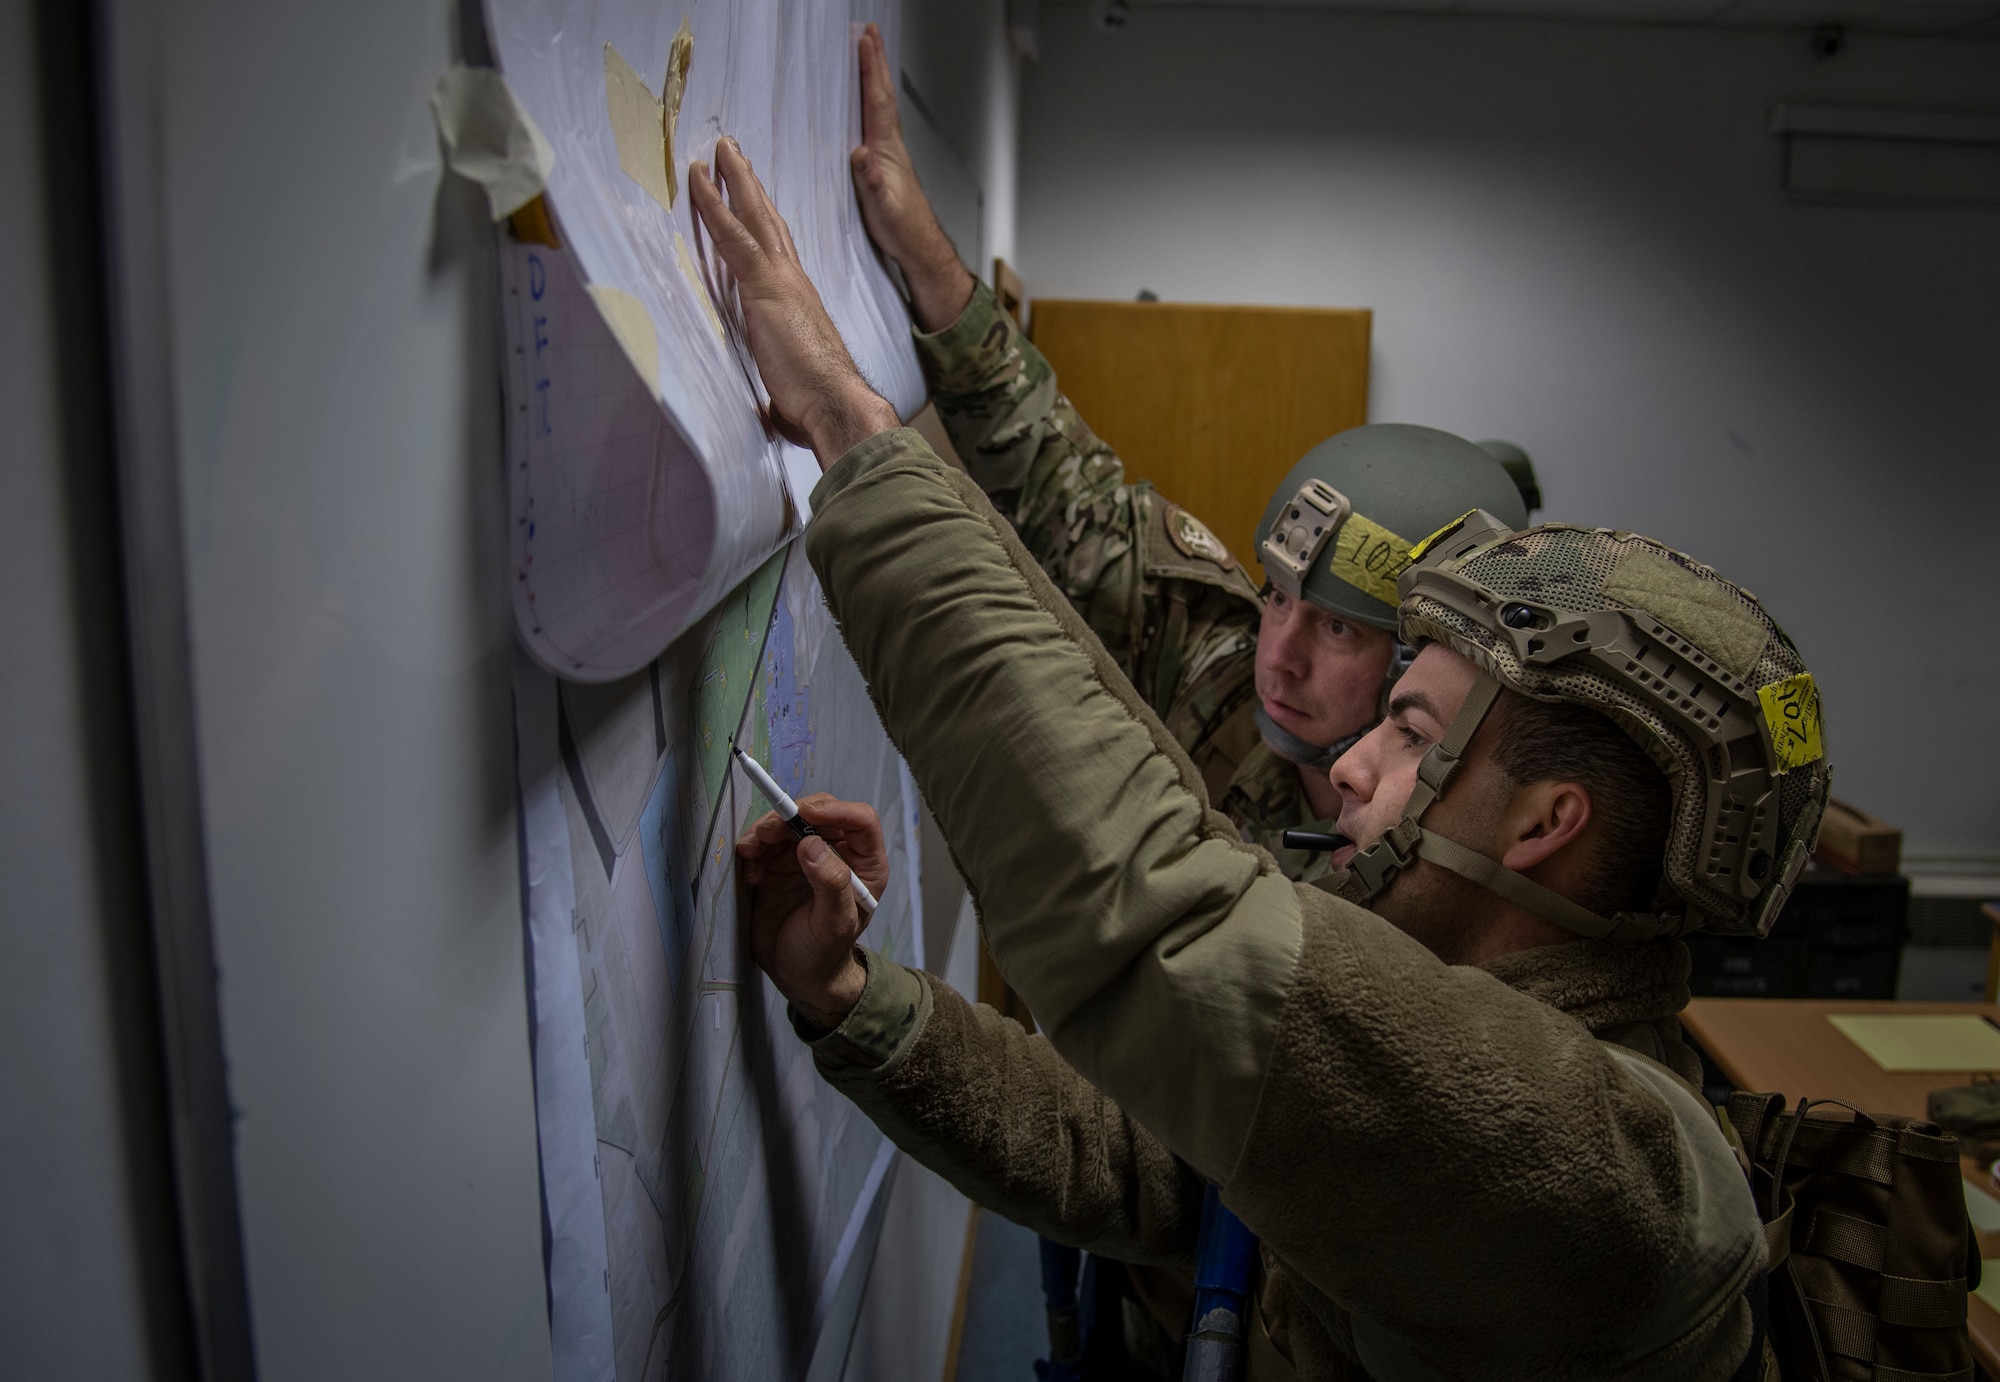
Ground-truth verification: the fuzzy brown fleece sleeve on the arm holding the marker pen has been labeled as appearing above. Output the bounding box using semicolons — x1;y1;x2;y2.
812;956;1202;1266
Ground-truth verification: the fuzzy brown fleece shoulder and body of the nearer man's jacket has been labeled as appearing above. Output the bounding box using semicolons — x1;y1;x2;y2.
1222;908;1764;1382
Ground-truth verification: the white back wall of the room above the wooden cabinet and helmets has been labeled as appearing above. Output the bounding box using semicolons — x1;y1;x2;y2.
1020;6;2000;860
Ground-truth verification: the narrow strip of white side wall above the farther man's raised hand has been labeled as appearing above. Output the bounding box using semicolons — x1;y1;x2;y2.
902;0;1020;278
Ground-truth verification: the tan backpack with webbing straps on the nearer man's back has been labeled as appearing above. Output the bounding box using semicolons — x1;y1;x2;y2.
1726;1094;1980;1382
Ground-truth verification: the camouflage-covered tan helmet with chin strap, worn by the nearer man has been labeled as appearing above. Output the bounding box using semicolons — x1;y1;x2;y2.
1340;512;1830;940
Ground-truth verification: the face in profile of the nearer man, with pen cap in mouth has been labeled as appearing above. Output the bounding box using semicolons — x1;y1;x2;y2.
1332;644;1478;868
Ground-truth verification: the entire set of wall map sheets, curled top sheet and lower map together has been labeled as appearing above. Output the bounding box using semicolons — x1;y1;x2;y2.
488;0;956;1382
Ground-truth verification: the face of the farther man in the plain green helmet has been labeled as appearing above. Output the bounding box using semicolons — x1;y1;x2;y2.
1256;590;1396;744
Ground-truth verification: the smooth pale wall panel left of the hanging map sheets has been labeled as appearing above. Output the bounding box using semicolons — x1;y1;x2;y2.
160;0;550;1382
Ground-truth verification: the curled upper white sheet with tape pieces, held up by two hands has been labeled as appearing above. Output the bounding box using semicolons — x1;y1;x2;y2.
488;0;924;680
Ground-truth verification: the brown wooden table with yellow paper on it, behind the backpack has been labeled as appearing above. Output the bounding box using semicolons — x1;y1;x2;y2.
1680;998;2000;1378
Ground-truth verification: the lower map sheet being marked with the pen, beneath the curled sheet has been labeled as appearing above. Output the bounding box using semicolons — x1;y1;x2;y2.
514;544;936;1382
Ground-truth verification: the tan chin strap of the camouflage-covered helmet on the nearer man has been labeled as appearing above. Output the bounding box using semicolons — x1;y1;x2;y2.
1338;672;1664;940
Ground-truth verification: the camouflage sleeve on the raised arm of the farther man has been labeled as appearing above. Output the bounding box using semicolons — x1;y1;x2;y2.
916;284;1154;676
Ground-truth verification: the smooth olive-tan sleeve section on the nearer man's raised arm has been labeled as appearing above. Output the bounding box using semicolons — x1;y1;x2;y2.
806;430;1300;1180
